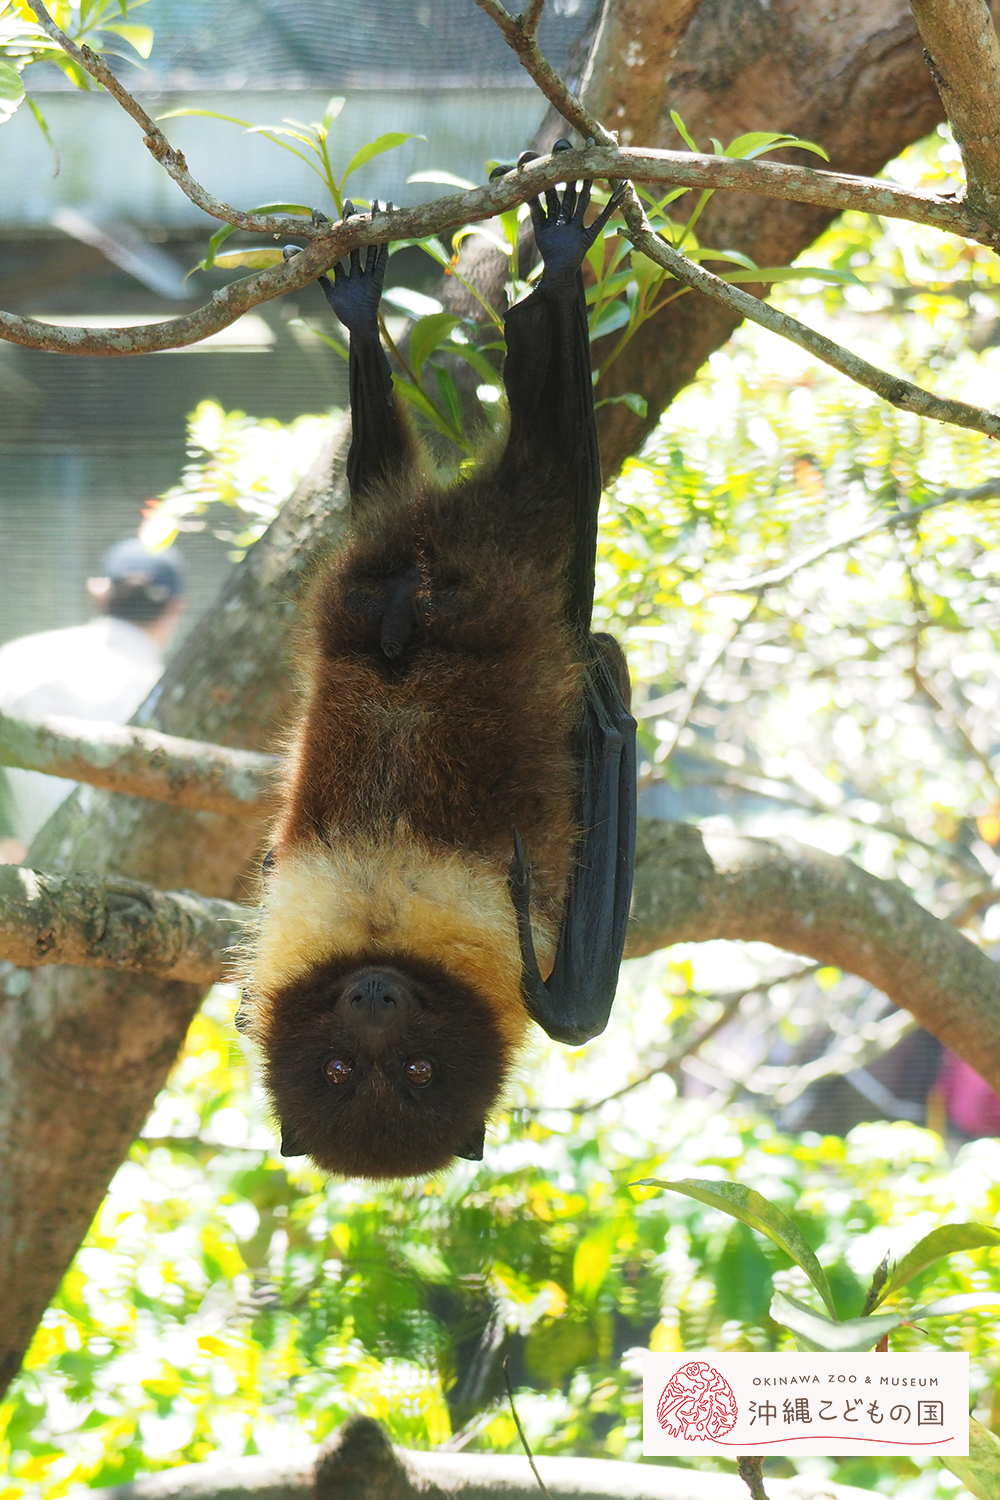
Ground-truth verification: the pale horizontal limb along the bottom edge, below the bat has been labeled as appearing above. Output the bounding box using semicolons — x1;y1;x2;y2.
93;1416;871;1500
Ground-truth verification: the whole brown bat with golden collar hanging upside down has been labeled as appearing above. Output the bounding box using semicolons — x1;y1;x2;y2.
237;143;636;1178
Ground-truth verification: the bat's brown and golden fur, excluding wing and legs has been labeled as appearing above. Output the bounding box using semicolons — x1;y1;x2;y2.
244;462;583;1176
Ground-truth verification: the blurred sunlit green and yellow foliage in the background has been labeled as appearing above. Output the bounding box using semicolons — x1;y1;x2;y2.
0;134;1000;1500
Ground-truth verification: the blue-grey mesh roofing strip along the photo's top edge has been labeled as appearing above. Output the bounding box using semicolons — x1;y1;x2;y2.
36;0;592;93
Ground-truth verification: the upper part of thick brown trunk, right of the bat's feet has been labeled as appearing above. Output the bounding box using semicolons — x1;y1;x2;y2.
586;0;945;476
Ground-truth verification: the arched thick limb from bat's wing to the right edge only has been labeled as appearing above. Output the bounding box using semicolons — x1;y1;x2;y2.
627;821;1000;1092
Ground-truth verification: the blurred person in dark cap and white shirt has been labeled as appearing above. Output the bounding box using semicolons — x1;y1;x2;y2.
0;537;184;864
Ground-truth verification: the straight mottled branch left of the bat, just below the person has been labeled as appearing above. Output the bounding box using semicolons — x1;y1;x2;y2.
0;714;279;818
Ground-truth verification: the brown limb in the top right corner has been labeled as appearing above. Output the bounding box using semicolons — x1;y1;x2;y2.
910;0;1000;224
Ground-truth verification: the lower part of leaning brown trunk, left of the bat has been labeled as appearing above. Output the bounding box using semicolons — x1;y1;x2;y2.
0;434;346;1389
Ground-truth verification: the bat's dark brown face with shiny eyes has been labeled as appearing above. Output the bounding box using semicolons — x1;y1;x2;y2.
261;957;510;1178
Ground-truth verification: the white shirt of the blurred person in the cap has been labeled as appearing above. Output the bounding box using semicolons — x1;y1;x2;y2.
0;615;163;846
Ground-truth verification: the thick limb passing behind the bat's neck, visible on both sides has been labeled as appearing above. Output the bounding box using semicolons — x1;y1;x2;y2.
0;819;1000;1092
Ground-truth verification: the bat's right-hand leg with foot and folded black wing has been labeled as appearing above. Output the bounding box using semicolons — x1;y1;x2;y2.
502;170;636;1046
